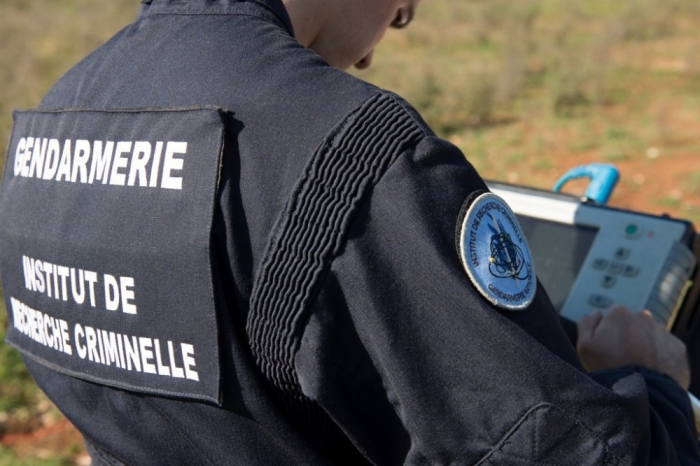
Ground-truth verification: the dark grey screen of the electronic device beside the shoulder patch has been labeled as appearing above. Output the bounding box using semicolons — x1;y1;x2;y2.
517;215;598;312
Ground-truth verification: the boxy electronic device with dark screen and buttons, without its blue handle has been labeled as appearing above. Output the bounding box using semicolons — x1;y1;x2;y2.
488;182;697;328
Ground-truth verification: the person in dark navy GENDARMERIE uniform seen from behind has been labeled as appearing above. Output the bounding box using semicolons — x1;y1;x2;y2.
3;0;700;465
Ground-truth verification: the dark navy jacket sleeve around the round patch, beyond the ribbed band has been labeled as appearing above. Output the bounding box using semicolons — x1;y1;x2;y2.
295;136;700;465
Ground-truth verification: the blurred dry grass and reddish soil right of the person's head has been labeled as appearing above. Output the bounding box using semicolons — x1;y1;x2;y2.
355;0;700;224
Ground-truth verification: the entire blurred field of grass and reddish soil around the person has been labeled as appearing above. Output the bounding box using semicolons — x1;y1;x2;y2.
0;0;700;465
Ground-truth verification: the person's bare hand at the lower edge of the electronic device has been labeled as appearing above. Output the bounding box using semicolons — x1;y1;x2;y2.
576;307;690;390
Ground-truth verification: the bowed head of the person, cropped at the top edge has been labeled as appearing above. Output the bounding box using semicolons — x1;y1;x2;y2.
283;0;418;69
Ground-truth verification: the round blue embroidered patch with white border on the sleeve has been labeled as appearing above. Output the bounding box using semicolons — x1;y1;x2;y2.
458;193;537;311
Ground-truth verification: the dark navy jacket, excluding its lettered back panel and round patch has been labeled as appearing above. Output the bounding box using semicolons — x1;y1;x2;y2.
13;0;700;465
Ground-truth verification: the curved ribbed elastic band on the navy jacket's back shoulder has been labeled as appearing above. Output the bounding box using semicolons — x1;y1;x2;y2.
247;93;423;424
